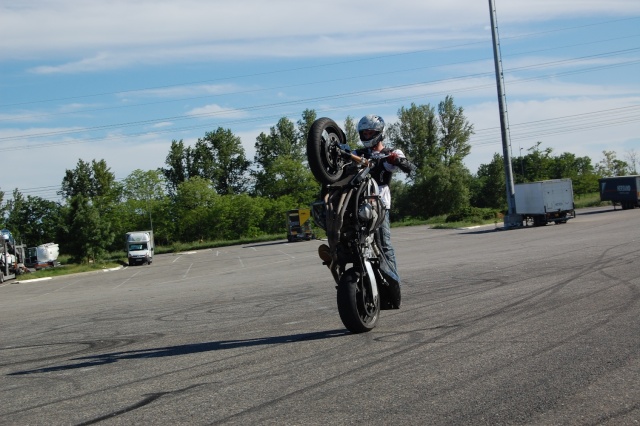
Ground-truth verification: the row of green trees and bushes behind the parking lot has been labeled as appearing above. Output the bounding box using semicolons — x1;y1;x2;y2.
0;96;637;261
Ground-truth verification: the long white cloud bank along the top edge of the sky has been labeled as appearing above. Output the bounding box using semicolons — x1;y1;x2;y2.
6;0;640;73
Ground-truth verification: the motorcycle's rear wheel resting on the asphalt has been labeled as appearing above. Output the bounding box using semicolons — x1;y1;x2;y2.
338;268;380;333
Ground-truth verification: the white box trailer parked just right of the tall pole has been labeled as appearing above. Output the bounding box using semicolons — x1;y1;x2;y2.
515;179;576;226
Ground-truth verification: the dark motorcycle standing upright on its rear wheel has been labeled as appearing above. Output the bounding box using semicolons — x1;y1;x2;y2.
307;117;401;333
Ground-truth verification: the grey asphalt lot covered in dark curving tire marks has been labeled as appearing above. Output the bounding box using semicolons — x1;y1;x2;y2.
0;207;640;425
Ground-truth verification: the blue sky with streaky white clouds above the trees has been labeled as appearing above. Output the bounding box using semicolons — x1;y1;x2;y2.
0;0;640;201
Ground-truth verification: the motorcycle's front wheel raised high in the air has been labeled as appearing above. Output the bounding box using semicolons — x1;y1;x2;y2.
307;117;346;185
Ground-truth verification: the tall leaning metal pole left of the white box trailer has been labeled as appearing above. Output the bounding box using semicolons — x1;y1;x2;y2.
489;0;522;229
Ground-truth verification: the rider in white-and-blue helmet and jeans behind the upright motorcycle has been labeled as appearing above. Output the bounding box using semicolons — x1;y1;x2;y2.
355;115;416;281
